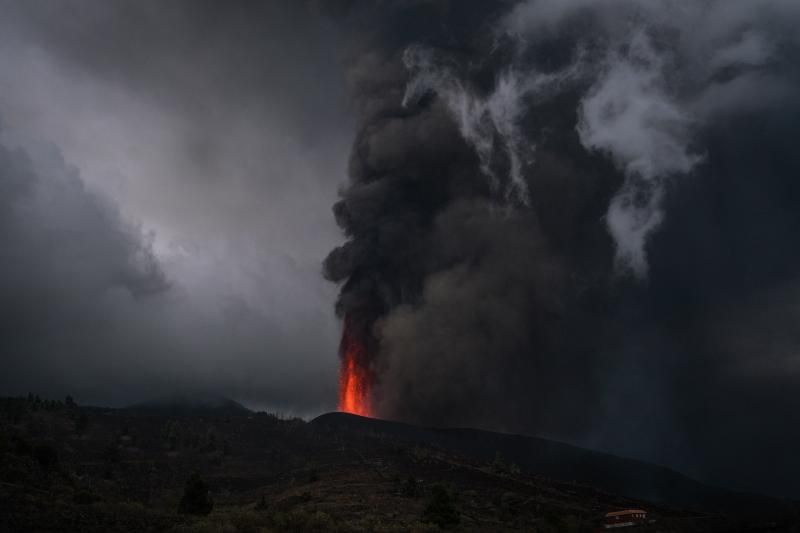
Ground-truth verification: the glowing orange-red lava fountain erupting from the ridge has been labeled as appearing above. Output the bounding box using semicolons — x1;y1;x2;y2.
339;318;372;416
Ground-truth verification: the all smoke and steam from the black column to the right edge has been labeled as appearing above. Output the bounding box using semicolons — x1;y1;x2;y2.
324;0;800;496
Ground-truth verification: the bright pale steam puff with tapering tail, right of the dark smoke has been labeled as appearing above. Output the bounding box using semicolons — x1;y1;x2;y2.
578;31;700;278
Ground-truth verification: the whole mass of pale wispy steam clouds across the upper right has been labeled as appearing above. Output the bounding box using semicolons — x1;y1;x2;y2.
403;0;800;279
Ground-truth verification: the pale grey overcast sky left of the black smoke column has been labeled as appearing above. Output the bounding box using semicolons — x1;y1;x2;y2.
0;0;353;414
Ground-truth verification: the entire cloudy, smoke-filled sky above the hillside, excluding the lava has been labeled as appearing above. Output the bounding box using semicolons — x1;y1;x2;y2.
0;0;800;497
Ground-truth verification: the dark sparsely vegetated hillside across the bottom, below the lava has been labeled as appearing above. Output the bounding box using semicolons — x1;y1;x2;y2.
0;392;797;533
